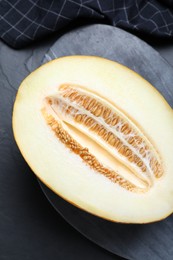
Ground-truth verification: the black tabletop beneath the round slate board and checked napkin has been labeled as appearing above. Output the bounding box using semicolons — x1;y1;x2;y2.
0;27;173;260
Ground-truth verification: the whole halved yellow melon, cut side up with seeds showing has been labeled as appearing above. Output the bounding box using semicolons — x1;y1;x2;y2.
13;56;173;223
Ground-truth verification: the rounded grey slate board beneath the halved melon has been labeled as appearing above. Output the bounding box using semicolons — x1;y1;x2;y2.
38;25;173;260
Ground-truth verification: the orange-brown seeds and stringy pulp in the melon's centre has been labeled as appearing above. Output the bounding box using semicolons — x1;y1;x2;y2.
44;84;163;191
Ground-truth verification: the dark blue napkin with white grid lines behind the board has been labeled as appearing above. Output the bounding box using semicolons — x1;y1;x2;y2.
0;0;173;48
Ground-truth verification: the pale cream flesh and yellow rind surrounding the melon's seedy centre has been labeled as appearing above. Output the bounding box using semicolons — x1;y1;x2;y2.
13;56;173;223
